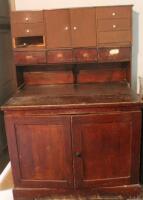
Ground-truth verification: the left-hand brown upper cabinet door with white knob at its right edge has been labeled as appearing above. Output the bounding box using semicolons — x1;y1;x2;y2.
45;9;71;48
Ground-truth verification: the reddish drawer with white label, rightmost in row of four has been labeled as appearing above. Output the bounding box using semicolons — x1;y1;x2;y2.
98;47;131;62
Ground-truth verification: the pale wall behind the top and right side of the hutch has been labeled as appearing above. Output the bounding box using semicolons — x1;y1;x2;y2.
11;0;143;89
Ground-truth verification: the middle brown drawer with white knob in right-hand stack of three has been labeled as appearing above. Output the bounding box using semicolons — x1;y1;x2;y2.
97;19;131;31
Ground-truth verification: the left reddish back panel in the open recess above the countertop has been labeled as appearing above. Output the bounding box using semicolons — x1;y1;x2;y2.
24;71;73;85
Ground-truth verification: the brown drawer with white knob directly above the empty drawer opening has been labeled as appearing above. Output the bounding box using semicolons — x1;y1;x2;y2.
12;23;45;37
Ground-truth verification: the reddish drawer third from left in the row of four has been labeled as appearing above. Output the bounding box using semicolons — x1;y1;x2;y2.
74;49;97;62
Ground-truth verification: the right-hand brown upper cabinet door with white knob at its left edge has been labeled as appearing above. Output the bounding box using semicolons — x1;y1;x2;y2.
70;8;96;47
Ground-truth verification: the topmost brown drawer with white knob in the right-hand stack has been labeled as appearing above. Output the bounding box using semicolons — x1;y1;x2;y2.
96;6;132;19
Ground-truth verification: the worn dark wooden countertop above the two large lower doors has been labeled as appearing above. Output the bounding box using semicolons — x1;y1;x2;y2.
2;83;139;110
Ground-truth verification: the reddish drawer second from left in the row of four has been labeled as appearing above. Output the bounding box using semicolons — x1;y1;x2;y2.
48;50;73;63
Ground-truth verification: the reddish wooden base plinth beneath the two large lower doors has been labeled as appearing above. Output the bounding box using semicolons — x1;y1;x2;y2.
13;184;141;200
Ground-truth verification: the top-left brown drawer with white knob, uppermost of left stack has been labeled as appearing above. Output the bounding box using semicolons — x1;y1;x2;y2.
11;11;43;23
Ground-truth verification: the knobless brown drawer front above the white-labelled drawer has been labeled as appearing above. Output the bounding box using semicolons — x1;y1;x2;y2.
97;31;131;44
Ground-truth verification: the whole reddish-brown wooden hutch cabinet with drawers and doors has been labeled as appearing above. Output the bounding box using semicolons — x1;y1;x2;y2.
3;5;141;200
